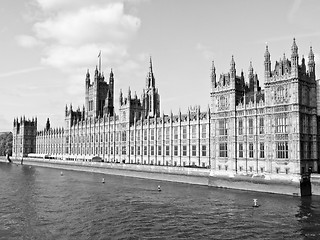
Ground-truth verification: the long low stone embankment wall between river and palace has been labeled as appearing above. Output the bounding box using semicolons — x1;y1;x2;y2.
0;158;320;196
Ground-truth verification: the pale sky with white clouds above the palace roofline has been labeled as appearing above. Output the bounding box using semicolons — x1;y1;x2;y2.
0;0;320;132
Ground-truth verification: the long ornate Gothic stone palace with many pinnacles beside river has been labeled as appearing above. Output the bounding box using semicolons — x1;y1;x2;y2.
13;39;320;179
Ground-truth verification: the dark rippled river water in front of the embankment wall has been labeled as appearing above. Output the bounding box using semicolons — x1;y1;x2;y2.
0;163;320;240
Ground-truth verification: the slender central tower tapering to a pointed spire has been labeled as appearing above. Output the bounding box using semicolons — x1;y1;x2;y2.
142;57;160;117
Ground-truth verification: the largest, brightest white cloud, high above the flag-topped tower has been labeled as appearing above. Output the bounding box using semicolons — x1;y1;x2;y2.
34;3;140;45
